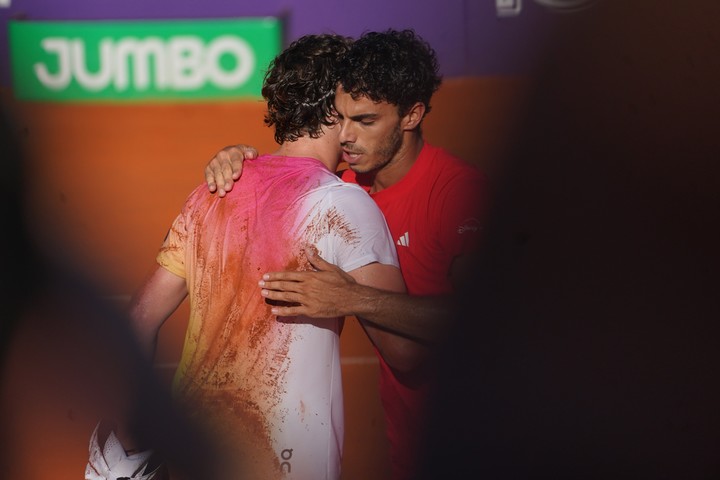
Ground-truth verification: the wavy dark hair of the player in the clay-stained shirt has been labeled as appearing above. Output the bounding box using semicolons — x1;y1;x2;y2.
262;34;352;143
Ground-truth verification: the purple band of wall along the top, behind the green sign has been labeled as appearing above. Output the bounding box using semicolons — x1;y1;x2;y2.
0;0;567;87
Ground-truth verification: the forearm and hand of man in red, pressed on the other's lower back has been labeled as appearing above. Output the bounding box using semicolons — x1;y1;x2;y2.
260;251;450;344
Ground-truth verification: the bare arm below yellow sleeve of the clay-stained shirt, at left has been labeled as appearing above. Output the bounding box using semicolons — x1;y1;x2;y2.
129;265;187;358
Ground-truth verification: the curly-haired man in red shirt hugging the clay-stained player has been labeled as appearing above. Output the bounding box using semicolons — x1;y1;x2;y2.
206;30;485;480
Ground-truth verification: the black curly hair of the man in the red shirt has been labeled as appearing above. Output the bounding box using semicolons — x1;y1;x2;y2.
339;29;442;116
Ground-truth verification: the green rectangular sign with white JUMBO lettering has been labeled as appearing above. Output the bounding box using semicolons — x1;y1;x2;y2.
9;18;281;101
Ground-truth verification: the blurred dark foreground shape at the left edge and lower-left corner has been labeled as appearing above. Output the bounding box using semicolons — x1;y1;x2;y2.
0;112;218;480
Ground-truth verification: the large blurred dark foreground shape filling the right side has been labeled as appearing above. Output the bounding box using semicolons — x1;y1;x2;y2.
425;1;720;479
